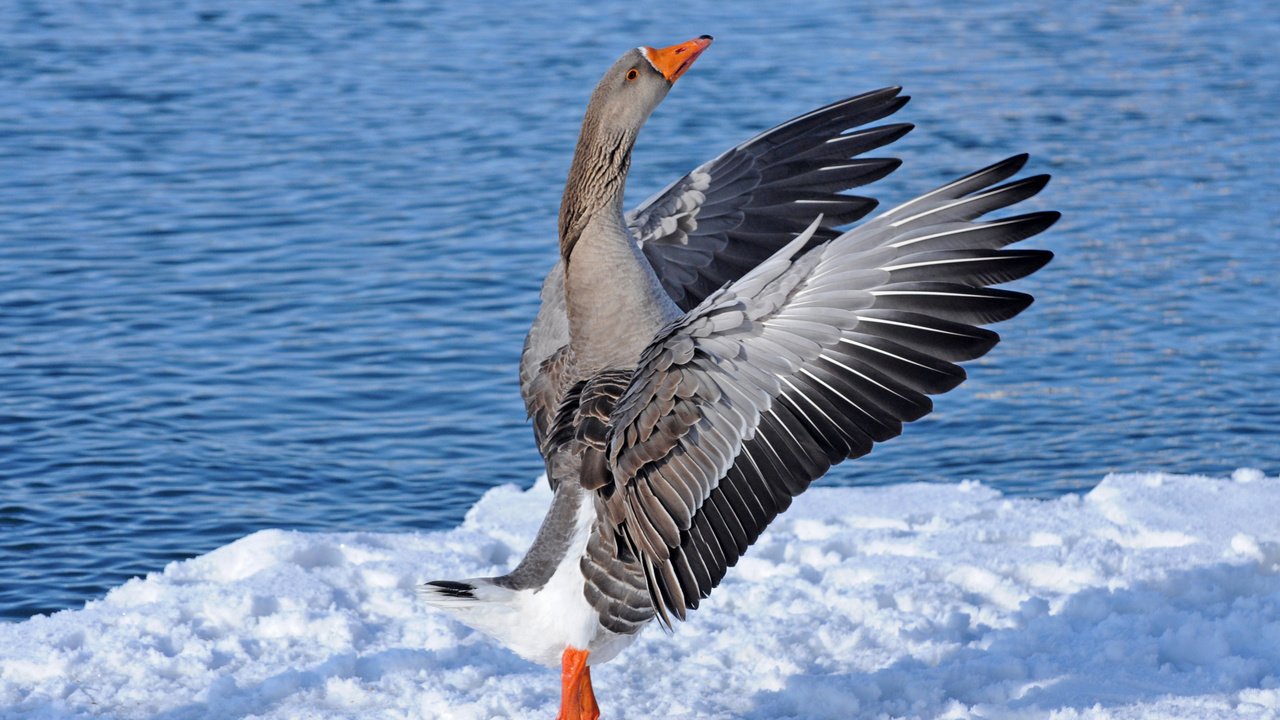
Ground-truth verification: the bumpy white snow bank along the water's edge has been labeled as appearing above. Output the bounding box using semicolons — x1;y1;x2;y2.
0;470;1280;720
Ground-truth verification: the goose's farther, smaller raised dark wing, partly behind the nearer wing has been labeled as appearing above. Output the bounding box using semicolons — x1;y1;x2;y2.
626;87;911;311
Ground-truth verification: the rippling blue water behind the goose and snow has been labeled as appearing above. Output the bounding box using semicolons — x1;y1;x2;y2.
0;0;1280;619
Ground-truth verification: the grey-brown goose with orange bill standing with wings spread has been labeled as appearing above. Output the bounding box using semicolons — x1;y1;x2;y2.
421;36;1059;720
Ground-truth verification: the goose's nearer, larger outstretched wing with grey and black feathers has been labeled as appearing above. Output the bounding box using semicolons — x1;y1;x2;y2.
602;155;1059;623
